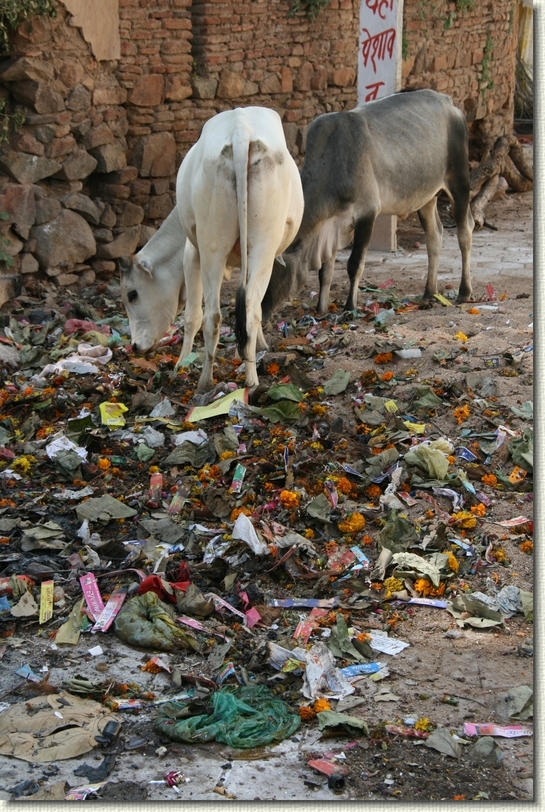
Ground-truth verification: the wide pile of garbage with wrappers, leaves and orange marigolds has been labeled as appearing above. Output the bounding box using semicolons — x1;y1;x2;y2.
0;286;533;797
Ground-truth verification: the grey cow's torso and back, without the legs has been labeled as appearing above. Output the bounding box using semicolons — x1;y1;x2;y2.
293;90;467;233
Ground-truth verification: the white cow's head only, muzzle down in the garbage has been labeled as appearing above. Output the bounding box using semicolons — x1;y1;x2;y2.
119;254;185;353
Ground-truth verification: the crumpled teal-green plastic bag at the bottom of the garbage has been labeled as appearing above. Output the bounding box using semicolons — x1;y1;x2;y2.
155;685;301;749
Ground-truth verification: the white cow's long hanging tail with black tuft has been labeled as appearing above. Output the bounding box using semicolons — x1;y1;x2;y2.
233;119;251;358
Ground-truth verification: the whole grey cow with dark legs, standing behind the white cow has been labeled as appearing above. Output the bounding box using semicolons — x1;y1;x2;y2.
262;90;473;318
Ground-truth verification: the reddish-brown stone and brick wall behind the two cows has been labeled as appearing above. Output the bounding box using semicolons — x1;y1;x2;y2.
0;0;516;298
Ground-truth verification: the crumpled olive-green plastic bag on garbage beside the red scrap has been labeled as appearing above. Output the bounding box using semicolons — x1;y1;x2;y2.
115;592;198;651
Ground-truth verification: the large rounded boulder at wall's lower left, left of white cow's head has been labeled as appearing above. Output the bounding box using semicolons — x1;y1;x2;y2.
30;209;96;268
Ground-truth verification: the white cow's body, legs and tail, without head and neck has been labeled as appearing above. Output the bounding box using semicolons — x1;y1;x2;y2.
176;107;303;392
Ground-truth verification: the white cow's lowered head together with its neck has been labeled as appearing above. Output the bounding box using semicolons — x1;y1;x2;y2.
119;207;186;357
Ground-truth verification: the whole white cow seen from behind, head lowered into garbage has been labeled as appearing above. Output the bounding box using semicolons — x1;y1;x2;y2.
120;107;304;392
